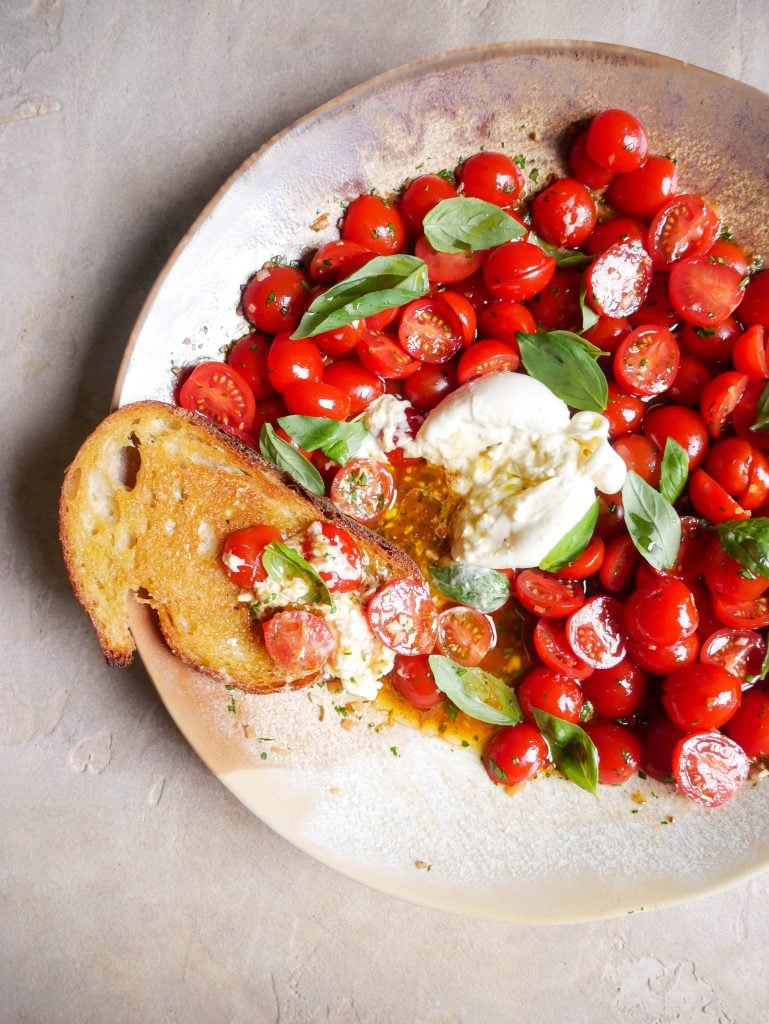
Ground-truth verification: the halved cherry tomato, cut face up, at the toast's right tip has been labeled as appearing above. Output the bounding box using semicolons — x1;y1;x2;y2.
366;580;437;654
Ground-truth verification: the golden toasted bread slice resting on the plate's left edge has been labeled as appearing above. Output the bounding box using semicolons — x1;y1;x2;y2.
59;401;420;692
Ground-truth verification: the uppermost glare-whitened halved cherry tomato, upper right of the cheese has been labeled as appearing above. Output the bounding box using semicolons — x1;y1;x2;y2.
585;242;651;318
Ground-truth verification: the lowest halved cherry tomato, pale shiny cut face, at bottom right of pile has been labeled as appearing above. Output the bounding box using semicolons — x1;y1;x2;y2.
673;732;750;807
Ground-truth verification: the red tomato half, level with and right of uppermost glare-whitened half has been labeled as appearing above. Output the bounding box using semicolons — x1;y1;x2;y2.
668;256;742;327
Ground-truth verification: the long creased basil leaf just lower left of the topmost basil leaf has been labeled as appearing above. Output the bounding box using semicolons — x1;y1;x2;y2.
291;253;430;339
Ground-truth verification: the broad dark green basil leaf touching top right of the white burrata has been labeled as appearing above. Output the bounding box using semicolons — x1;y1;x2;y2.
516;331;608;413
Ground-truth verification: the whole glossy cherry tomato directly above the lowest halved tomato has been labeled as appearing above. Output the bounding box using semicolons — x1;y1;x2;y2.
663;665;741;732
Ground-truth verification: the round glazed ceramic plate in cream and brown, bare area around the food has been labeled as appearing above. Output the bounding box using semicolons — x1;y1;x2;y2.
115;42;769;922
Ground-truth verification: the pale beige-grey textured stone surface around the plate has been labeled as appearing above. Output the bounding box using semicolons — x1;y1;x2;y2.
0;0;769;1024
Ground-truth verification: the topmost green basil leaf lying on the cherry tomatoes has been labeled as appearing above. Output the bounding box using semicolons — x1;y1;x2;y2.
422;196;526;253
